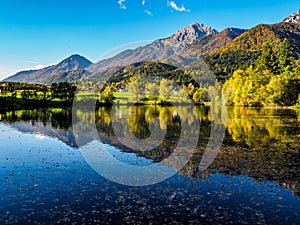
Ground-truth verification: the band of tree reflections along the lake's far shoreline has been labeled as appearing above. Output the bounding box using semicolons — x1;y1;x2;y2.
0;106;300;148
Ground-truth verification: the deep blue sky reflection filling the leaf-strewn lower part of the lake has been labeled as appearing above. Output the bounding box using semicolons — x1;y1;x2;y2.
0;123;300;224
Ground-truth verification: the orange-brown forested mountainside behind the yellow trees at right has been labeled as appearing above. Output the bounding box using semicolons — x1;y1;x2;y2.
205;22;300;80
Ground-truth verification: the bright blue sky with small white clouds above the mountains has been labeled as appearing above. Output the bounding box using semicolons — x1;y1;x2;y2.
0;0;300;79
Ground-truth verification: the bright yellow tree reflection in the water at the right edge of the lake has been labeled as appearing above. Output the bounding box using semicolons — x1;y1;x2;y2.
226;107;299;147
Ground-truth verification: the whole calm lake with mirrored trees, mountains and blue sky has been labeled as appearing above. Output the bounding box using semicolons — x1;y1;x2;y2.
0;106;300;224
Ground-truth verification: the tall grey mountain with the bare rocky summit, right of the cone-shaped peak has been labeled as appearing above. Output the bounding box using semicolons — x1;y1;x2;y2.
41;23;246;83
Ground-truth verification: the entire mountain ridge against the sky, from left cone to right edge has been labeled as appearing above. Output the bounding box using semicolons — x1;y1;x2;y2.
4;10;300;84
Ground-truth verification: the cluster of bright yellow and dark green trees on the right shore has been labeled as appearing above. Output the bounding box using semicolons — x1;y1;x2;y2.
222;39;300;107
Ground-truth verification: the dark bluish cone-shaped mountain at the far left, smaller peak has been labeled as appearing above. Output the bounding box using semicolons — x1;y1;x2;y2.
4;55;93;83
